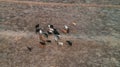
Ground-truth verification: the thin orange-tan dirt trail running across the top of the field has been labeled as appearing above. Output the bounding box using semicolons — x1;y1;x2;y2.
0;0;120;8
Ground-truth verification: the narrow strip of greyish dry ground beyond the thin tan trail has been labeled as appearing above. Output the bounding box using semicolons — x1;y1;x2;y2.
5;0;120;5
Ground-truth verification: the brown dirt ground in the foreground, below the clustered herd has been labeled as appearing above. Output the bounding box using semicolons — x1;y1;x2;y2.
0;31;120;67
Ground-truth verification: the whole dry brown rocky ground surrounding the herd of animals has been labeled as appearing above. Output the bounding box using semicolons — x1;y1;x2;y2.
0;0;120;67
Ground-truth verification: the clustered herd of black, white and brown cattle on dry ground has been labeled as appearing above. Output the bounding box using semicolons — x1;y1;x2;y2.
35;24;72;46
